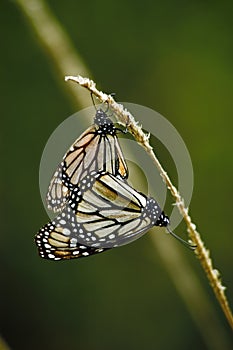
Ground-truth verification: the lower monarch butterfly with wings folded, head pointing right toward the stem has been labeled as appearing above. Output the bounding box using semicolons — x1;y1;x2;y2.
35;172;195;260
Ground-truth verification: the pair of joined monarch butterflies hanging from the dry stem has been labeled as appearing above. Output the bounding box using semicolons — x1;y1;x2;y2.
35;110;195;260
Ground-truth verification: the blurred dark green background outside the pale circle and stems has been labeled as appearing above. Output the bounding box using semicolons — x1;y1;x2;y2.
0;0;233;350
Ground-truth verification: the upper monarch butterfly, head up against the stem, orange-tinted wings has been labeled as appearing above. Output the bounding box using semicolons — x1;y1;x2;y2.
46;109;128;212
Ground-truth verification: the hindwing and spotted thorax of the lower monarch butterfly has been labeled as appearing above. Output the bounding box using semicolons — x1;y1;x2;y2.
69;174;162;248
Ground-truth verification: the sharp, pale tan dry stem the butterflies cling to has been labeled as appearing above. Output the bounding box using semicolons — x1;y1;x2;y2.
65;75;233;329
